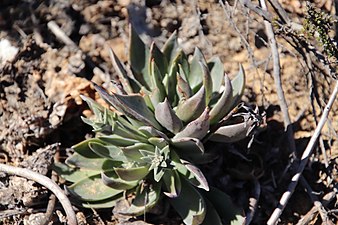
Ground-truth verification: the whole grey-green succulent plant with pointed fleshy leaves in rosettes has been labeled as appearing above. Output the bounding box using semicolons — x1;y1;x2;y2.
55;27;260;224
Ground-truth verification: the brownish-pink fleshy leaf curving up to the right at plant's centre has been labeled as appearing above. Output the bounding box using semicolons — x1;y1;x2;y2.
173;108;209;140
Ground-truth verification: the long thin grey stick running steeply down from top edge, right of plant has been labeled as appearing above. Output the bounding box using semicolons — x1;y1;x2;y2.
259;0;296;156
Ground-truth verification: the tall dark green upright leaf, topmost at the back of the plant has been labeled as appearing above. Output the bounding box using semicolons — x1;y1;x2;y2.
129;26;151;90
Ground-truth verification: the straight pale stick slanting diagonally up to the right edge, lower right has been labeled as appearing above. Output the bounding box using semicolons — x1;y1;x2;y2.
267;81;338;225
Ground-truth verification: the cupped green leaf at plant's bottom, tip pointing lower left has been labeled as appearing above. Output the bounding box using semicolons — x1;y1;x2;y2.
123;183;161;216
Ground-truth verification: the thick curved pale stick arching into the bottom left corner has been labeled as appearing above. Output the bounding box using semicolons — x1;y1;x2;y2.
0;163;77;225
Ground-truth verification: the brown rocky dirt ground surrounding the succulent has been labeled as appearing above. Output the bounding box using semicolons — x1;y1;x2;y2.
0;0;338;225
